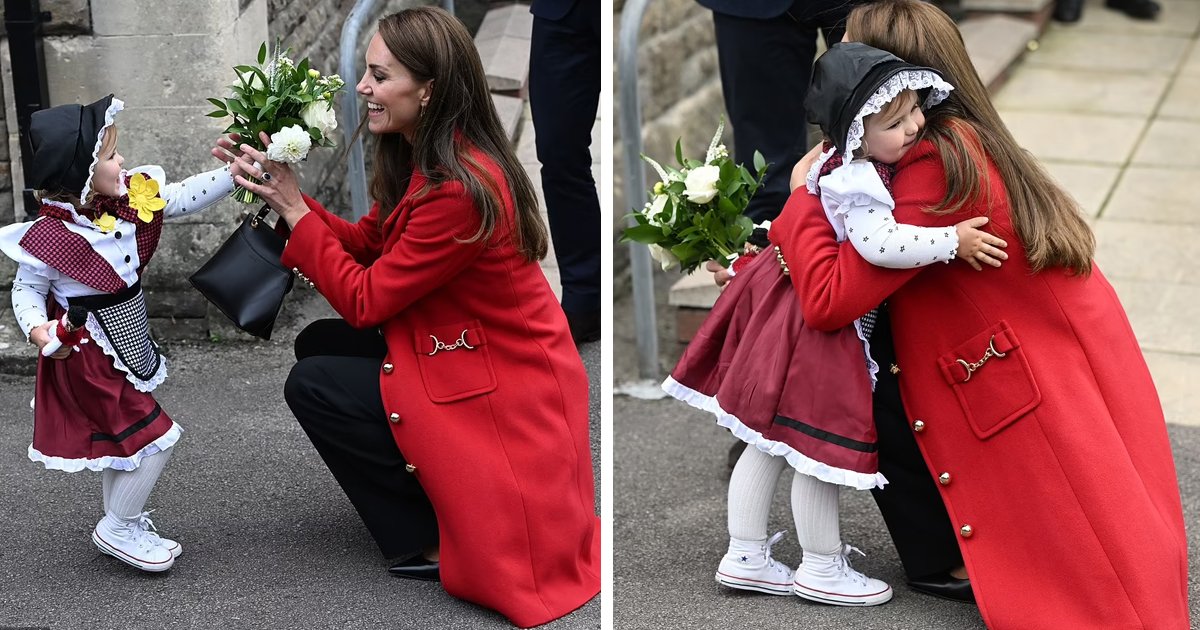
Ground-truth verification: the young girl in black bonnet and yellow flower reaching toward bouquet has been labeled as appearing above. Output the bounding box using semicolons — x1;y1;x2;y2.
0;95;233;571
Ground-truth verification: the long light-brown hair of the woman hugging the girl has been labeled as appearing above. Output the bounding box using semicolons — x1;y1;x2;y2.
846;0;1096;276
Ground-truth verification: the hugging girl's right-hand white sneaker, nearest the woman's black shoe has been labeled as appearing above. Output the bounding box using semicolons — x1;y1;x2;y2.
792;545;892;606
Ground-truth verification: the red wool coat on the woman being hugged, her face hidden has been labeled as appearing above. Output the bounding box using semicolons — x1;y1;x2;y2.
770;140;1188;630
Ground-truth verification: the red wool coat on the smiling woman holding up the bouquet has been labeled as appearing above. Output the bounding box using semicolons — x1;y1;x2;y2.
283;151;600;628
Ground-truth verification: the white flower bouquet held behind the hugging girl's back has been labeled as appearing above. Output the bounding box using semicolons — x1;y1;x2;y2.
623;118;767;272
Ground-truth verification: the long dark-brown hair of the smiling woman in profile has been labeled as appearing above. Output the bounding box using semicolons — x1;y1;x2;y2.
371;7;548;260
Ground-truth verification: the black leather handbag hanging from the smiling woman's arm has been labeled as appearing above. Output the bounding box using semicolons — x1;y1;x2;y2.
187;205;294;340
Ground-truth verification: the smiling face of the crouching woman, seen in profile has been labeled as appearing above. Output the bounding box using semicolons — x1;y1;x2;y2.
355;32;433;142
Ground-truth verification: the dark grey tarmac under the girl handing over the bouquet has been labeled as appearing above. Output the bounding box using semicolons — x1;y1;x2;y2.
0;290;600;630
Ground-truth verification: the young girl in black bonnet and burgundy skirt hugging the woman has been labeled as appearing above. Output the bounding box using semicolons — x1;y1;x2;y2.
662;43;1004;606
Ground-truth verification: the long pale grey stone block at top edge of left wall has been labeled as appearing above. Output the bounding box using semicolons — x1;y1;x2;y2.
91;0;241;36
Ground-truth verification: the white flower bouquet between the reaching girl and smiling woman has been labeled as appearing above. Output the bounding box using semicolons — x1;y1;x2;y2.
209;42;344;203
